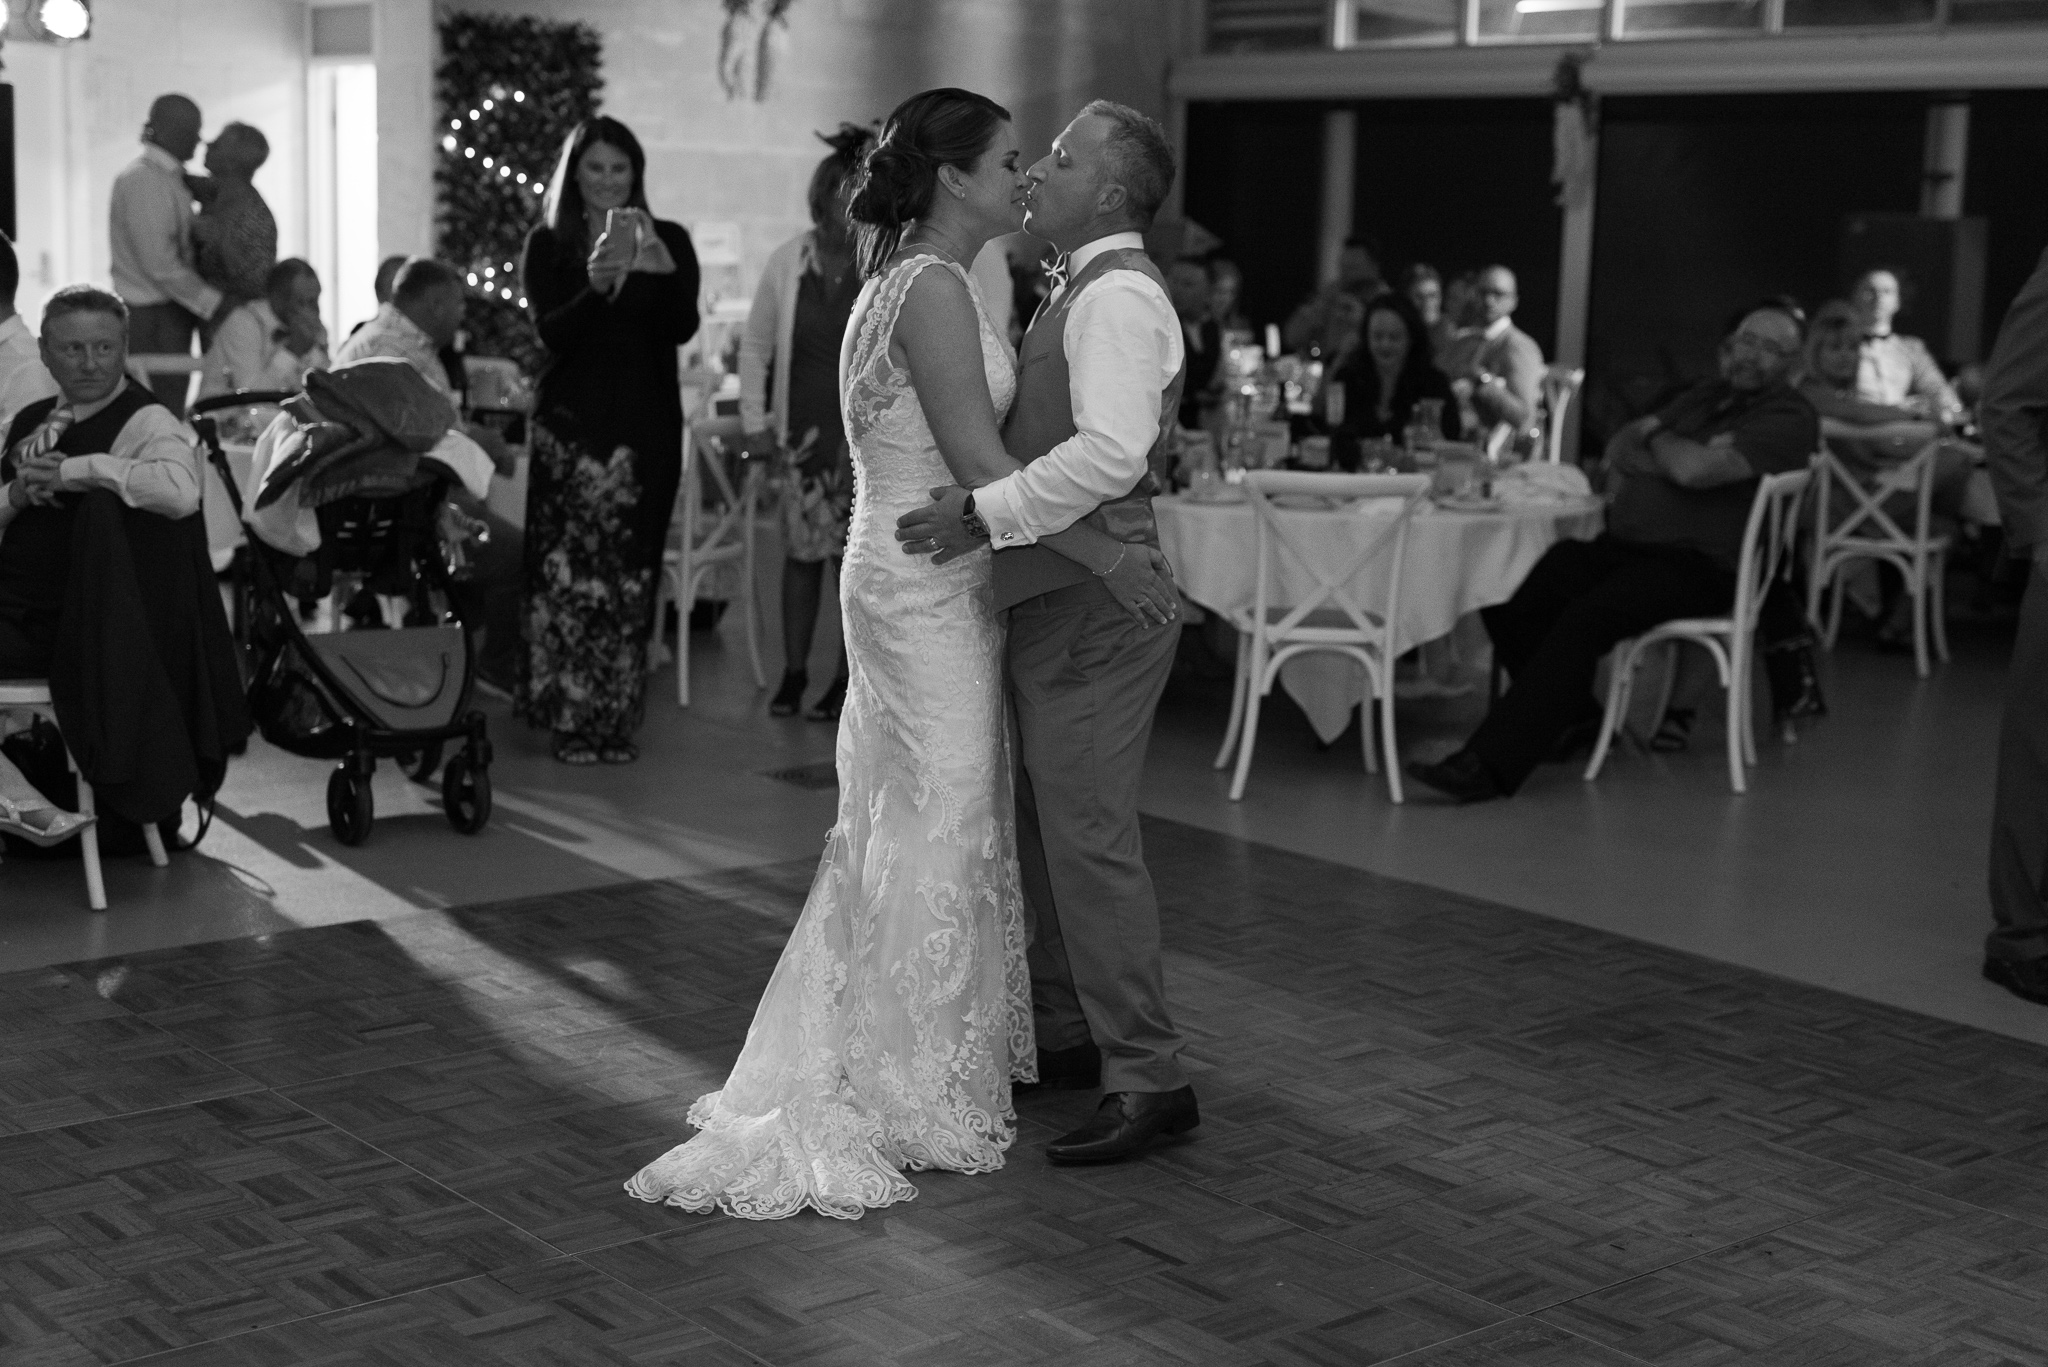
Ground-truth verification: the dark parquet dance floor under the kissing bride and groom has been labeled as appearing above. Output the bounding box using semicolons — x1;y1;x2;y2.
0;822;2048;1367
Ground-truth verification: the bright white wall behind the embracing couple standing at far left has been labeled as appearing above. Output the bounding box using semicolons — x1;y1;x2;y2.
6;0;305;320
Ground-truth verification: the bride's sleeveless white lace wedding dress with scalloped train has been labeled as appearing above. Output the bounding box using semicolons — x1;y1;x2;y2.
627;256;1036;1219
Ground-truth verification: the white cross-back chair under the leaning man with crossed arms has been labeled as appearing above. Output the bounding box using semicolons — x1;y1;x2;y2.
1585;469;1812;793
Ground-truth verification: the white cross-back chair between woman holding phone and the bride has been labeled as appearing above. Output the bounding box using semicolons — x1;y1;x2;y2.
653;416;768;707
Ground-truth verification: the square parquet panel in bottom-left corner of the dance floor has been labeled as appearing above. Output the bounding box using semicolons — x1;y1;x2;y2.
0;1094;555;1363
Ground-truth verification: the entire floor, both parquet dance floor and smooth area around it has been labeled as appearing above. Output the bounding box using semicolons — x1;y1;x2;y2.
0;573;2048;1367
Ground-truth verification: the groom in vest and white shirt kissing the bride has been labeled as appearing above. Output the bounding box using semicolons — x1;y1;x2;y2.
897;100;1200;1162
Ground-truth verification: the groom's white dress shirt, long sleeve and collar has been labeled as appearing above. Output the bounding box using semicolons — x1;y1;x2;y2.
975;232;1186;547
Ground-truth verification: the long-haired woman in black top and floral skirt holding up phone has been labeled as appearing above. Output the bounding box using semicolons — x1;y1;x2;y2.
514;117;696;764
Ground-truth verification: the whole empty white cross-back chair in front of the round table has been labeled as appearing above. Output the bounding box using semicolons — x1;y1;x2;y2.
1217;469;1430;801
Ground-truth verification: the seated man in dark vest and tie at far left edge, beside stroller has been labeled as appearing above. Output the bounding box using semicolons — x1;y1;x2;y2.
0;285;201;678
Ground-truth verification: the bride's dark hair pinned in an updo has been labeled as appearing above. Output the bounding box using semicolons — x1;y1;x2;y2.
846;86;1010;277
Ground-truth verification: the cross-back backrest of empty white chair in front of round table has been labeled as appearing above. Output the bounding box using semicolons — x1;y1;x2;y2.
1245;469;1430;652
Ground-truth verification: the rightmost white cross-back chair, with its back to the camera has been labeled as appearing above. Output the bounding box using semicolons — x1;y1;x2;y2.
1806;443;1948;678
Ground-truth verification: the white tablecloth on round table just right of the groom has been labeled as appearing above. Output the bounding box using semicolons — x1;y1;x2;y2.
1153;496;1599;742
